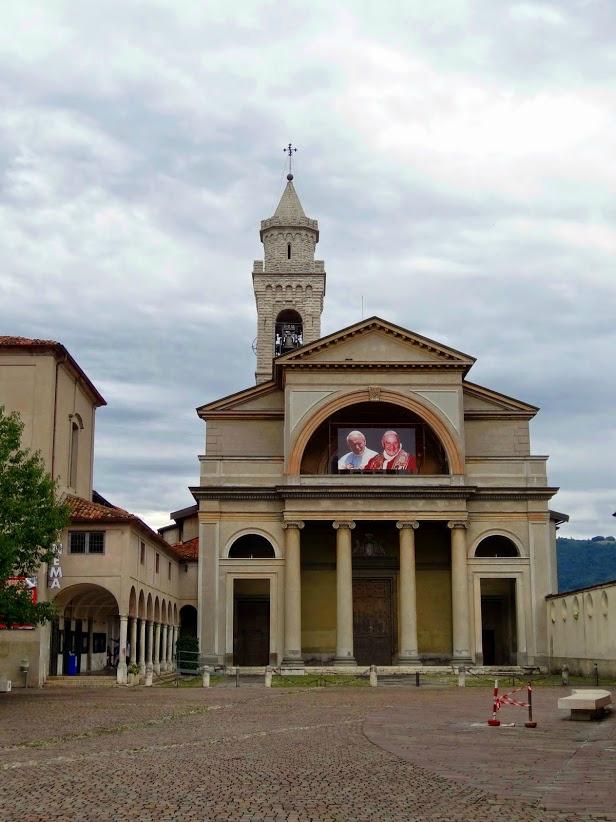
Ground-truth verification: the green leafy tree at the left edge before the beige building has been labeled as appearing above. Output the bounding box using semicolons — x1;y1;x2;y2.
0;405;69;627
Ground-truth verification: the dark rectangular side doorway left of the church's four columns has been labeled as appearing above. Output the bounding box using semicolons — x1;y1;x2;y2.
233;579;270;667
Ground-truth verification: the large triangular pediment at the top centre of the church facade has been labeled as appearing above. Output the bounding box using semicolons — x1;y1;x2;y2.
276;317;475;373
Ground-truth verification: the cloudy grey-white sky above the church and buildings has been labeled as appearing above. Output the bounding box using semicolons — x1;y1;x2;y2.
0;0;616;536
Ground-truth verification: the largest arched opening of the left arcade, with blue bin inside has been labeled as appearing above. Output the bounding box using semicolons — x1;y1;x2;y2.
49;583;120;676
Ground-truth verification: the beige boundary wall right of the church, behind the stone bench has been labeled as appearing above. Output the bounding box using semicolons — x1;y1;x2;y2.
547;580;616;677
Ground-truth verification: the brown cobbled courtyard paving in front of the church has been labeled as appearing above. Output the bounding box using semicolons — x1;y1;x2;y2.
0;686;616;822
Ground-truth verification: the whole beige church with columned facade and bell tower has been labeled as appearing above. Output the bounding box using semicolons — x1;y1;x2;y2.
191;175;558;671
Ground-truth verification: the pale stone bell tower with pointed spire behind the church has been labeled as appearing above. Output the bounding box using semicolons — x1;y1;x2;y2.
252;172;325;383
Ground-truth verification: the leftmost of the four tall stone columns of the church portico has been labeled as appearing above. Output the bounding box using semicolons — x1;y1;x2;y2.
282;522;304;670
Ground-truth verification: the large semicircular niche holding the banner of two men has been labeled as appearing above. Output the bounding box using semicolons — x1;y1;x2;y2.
300;400;449;474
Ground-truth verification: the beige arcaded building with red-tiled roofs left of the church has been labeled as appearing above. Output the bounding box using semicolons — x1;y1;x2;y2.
0;337;190;686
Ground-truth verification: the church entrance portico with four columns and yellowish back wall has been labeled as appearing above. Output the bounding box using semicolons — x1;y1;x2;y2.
285;519;470;666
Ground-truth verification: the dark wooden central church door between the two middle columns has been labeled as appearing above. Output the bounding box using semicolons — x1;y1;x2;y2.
353;577;393;665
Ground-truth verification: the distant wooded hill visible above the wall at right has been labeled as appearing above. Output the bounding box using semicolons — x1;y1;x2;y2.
556;536;616;592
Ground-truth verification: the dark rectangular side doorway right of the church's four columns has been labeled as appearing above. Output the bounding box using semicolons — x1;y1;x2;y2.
481;579;518;665
